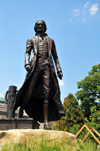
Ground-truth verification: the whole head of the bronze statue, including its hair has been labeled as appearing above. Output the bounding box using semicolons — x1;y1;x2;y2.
34;20;47;33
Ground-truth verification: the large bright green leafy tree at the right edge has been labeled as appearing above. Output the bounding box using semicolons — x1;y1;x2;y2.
75;64;100;119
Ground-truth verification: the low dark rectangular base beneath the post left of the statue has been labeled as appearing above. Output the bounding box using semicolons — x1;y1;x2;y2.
0;118;40;130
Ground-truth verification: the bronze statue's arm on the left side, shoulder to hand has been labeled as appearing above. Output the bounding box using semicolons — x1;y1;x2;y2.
25;38;32;71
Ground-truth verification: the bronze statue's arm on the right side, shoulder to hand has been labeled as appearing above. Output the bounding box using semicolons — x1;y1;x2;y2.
51;40;63;79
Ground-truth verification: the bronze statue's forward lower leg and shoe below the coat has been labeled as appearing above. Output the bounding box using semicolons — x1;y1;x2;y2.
44;103;51;130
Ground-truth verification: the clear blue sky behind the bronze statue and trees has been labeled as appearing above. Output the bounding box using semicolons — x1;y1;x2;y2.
0;0;100;102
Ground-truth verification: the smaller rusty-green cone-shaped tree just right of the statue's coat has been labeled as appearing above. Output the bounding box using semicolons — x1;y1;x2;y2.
56;93;85;134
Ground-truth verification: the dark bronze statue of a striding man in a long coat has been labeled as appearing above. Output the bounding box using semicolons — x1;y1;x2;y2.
15;20;64;125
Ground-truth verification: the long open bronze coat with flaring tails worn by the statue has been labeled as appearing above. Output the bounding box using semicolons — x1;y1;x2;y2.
15;34;64;122
